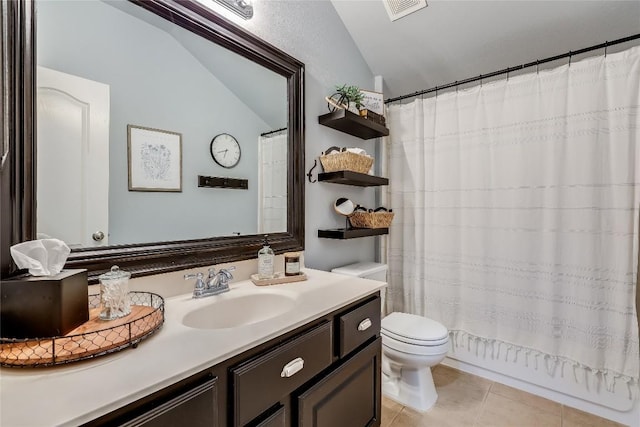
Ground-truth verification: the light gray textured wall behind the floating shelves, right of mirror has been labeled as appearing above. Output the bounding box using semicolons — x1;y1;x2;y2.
236;0;378;270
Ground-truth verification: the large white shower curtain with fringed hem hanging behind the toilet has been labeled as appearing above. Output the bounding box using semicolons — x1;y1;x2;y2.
386;48;640;390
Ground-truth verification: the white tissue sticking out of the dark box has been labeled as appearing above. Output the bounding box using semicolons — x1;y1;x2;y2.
10;239;71;276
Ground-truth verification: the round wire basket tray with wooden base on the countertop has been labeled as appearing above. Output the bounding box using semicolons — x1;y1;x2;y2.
0;292;164;368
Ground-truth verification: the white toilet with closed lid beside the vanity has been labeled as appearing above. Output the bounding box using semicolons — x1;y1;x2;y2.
331;262;449;411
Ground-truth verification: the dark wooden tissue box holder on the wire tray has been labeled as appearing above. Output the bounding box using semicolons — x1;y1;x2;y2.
0;269;89;338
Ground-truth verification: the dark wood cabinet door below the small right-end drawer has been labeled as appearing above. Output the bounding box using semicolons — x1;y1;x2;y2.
297;338;382;427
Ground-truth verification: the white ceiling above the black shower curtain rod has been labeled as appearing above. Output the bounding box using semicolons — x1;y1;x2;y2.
331;0;640;99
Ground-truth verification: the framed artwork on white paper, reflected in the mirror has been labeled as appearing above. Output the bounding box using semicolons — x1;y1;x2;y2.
127;125;182;192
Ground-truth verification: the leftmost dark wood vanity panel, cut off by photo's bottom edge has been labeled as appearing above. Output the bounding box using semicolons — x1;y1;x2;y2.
121;378;218;427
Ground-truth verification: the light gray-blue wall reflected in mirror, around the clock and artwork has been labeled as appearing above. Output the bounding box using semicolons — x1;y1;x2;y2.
37;1;271;244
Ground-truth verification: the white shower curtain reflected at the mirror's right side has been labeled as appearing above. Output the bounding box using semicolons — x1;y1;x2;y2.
258;129;288;234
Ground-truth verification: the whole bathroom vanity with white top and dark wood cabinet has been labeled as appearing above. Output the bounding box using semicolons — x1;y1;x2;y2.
0;269;384;427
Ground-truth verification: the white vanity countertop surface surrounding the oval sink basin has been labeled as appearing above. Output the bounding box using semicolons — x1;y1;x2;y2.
0;269;386;427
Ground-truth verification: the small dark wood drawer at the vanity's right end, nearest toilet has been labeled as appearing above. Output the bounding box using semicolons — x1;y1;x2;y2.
339;297;380;357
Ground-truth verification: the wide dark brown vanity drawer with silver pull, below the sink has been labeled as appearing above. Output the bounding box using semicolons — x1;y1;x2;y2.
231;321;333;426
